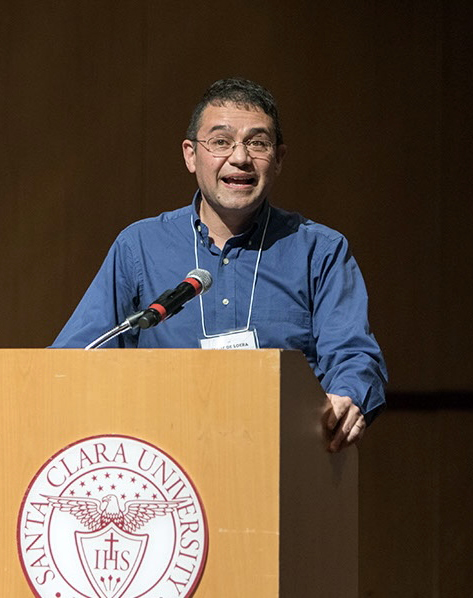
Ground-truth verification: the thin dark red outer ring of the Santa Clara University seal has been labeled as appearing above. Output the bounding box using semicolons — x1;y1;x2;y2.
16;434;209;598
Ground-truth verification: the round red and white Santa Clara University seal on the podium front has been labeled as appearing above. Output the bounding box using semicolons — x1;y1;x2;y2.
18;436;208;598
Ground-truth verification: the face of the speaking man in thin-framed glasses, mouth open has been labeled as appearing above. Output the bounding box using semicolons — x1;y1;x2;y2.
182;104;285;225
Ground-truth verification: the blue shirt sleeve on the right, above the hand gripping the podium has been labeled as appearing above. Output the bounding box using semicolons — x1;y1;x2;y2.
312;236;387;423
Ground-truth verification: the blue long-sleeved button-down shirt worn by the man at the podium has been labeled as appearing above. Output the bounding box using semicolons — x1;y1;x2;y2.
53;194;386;422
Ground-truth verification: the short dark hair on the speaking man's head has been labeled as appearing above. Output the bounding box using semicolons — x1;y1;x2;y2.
186;77;283;145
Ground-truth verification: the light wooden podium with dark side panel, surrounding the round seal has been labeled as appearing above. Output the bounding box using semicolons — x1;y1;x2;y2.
0;349;358;598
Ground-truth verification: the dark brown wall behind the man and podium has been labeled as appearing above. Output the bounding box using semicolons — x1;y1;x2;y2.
0;0;473;598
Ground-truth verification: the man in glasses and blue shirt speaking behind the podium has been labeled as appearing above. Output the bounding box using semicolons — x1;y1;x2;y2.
53;79;386;452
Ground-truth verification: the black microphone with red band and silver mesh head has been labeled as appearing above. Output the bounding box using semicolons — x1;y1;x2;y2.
138;269;212;329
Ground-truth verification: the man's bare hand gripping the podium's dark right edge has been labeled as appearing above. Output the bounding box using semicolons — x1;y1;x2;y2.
322;394;366;453
